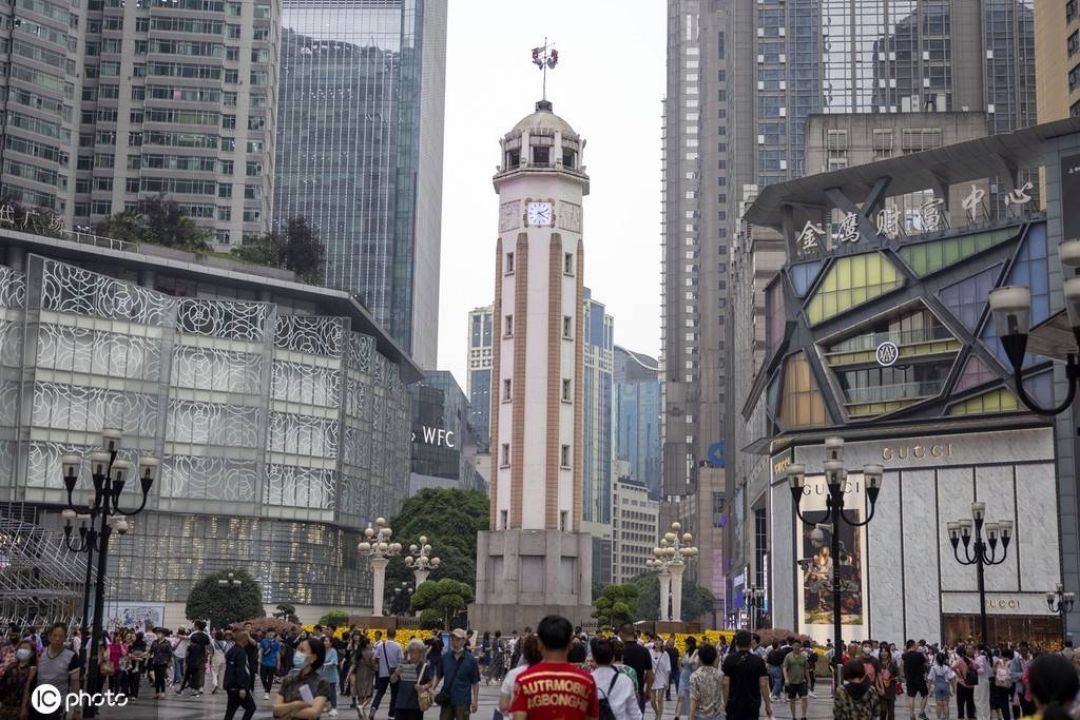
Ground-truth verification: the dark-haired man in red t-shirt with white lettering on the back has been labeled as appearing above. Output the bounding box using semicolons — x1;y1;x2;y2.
510;615;600;720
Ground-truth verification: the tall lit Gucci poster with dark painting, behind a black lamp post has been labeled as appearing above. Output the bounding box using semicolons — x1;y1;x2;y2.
795;473;867;643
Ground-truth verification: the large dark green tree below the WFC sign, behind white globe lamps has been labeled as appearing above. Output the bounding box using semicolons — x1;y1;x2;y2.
384;488;488;607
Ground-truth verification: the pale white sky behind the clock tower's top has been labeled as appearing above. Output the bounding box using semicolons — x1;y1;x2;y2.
438;0;666;390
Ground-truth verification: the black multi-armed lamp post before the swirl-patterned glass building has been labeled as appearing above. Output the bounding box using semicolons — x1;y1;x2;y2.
60;429;159;717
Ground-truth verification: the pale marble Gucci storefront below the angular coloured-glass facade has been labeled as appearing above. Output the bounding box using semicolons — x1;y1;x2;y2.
770;429;1061;643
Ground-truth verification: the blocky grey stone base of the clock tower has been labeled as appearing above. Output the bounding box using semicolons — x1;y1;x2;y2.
469;530;593;634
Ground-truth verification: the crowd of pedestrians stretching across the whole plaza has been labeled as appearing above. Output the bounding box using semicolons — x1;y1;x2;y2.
0;615;1080;720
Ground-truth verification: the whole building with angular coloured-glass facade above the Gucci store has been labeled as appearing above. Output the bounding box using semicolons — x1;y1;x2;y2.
732;119;1080;642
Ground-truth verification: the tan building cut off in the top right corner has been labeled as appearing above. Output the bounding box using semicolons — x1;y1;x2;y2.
1035;0;1080;123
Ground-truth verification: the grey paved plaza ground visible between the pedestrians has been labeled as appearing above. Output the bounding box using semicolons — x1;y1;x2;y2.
92;685;833;720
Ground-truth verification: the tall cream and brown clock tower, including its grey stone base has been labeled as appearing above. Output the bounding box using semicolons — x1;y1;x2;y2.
470;100;592;631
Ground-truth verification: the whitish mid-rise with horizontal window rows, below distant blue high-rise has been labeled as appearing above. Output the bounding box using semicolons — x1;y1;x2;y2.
611;472;660;583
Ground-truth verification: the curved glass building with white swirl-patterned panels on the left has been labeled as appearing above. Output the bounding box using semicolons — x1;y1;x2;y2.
0;233;419;616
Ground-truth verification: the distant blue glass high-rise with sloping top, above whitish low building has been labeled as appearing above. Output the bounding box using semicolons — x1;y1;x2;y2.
613;345;661;500
